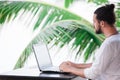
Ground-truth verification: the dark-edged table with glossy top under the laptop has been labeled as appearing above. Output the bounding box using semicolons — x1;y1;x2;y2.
0;68;86;80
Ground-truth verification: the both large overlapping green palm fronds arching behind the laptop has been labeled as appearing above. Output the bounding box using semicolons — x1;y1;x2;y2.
0;1;109;68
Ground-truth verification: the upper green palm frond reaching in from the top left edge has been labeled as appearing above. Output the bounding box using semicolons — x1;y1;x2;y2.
0;1;90;30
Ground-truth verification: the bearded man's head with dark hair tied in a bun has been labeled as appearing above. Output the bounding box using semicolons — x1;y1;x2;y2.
93;4;115;34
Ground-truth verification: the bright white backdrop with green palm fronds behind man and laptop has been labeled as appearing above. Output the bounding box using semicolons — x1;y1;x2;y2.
0;0;120;73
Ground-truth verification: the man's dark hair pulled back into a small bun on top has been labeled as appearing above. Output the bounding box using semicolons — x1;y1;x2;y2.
94;4;115;25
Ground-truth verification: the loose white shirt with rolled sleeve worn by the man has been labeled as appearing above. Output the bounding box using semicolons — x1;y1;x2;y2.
84;33;120;80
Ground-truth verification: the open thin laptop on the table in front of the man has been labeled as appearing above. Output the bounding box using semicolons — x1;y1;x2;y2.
32;43;69;74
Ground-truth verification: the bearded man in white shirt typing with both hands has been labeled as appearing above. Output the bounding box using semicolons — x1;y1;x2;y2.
59;4;120;80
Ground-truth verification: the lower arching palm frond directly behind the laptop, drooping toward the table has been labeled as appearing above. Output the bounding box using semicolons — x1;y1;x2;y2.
15;20;102;68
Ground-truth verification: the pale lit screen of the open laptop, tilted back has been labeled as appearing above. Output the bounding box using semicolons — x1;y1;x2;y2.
33;43;52;68
